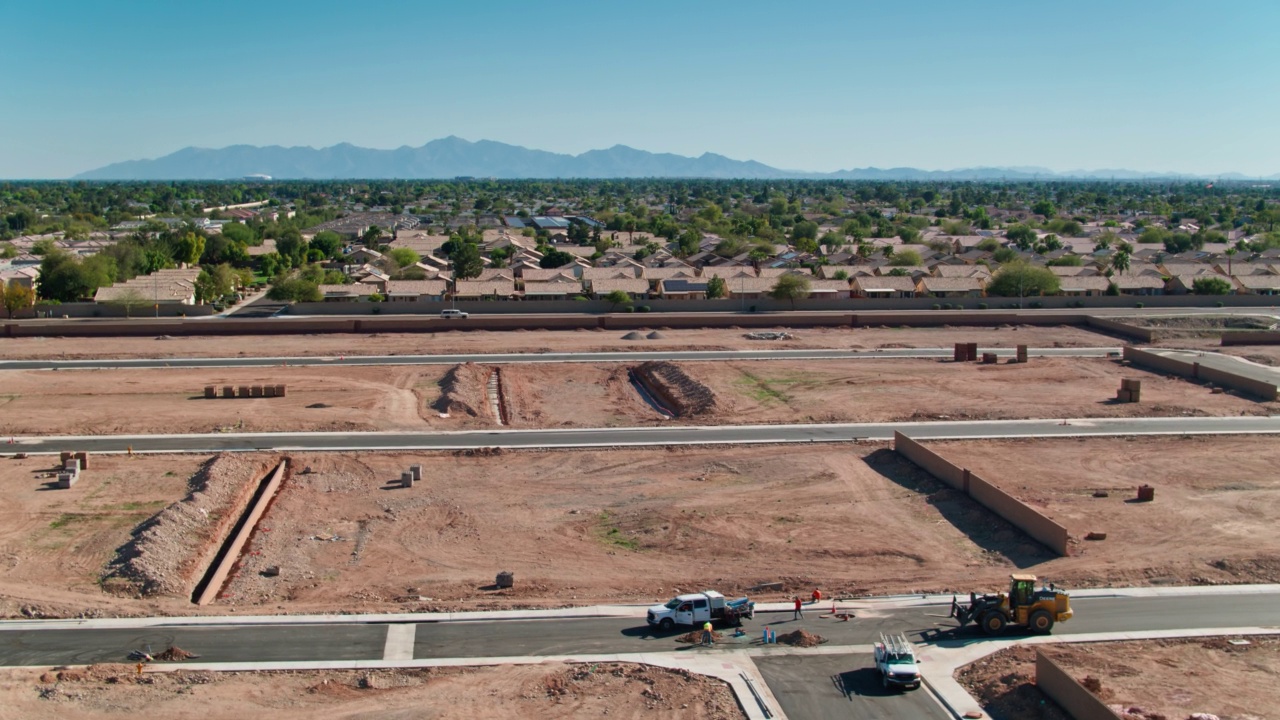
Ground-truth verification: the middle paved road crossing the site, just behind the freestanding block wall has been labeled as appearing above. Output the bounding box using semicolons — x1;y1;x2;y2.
10;415;1280;452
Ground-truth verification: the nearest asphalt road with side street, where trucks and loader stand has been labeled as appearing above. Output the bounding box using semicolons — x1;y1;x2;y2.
0;588;1280;719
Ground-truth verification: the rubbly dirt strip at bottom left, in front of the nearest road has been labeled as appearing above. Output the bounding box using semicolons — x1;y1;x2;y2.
0;662;744;720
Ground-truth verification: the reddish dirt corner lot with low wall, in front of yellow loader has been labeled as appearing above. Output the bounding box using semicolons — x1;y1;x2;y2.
956;635;1280;720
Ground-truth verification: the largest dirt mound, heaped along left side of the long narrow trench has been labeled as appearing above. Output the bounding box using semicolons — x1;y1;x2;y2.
102;454;279;596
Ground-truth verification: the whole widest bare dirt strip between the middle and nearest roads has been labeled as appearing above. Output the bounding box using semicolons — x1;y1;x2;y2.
0;437;1280;616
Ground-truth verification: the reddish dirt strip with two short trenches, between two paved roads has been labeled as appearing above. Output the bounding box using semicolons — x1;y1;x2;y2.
0;357;1264;436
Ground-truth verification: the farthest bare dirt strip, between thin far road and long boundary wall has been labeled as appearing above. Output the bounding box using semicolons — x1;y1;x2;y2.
0;324;1123;360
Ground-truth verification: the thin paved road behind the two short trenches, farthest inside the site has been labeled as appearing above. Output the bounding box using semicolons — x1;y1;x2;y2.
0;346;1120;370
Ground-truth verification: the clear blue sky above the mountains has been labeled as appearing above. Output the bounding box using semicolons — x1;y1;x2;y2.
0;0;1280;178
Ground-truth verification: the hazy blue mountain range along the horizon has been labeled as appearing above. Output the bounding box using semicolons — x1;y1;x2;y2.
73;136;1280;181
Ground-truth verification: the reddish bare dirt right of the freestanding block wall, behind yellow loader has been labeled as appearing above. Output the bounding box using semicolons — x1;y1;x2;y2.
927;436;1280;587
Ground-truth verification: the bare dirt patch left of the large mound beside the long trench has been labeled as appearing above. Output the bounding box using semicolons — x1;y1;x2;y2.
0;448;206;616
